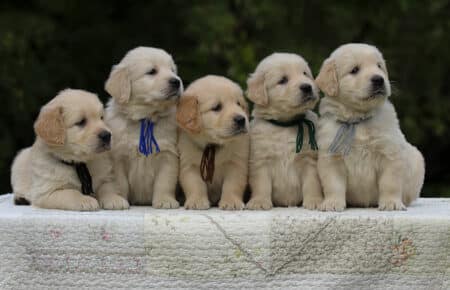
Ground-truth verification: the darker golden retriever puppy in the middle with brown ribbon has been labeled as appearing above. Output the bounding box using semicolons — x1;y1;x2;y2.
177;76;249;210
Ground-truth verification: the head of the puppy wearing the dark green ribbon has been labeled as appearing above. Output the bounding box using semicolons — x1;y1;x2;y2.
247;53;319;119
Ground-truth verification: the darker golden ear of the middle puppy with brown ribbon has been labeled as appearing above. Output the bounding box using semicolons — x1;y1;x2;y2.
177;95;201;134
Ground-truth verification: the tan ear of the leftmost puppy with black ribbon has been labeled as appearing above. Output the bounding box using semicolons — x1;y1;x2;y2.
34;106;66;146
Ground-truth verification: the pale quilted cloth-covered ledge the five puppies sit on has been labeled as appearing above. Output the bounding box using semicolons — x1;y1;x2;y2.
0;195;450;289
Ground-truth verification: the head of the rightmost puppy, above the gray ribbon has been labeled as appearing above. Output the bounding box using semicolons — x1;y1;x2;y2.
316;43;391;111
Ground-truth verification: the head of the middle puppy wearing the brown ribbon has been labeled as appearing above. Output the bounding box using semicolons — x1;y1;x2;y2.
177;76;248;144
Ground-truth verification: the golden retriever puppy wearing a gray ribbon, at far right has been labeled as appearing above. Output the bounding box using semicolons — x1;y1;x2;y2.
316;43;425;211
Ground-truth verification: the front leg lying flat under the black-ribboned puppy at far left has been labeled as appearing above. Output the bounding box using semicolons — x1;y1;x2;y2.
32;189;99;211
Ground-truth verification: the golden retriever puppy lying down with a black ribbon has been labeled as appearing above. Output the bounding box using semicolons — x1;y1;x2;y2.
11;89;117;210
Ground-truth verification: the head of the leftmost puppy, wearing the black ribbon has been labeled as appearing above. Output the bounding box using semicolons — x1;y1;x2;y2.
34;89;111;161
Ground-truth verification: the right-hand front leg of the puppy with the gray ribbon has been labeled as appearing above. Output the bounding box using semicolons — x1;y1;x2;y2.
378;160;406;210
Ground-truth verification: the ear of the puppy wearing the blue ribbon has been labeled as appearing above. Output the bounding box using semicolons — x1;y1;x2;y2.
105;66;131;104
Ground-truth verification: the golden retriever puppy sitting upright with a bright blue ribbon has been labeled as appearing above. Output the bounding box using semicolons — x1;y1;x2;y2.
100;47;183;208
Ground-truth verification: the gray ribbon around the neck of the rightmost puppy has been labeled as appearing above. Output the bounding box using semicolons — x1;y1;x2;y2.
328;117;370;156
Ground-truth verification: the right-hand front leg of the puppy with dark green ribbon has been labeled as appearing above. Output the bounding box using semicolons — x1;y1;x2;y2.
302;162;323;209
